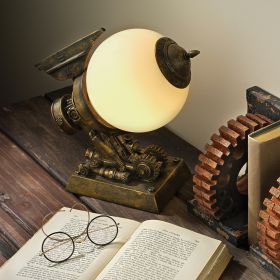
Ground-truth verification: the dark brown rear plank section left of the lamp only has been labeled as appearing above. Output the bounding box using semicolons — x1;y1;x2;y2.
0;97;89;183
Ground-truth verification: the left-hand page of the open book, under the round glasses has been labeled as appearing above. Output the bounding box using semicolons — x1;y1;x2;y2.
0;207;139;280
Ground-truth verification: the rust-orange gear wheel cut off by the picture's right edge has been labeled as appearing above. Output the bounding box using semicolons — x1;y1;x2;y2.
257;178;280;267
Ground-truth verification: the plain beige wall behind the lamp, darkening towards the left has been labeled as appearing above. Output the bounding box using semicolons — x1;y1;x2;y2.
0;0;280;149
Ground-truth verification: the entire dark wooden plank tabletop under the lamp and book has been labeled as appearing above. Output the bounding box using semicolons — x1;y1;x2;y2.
0;88;275;280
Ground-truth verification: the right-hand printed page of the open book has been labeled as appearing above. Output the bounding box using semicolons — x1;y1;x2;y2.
97;220;221;280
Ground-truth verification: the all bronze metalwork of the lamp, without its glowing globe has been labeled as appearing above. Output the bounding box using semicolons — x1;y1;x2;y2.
37;29;192;213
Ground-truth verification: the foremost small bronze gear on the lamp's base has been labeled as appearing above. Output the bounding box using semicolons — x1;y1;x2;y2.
133;154;162;182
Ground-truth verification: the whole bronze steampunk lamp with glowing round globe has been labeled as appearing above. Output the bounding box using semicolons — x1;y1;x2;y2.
36;29;199;213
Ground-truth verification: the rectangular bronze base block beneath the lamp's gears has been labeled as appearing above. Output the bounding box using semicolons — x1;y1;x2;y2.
66;157;191;213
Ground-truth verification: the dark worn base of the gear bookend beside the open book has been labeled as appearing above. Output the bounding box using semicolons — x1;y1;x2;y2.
187;199;248;247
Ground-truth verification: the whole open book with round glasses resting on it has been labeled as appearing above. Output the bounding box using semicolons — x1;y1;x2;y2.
0;207;231;280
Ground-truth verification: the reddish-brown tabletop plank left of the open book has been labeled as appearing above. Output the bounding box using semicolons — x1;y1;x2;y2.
0;133;78;264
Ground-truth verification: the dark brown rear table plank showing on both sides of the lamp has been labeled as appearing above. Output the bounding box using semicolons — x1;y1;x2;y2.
0;96;200;199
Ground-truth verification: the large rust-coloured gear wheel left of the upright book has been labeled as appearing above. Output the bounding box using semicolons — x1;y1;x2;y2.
193;114;272;220
